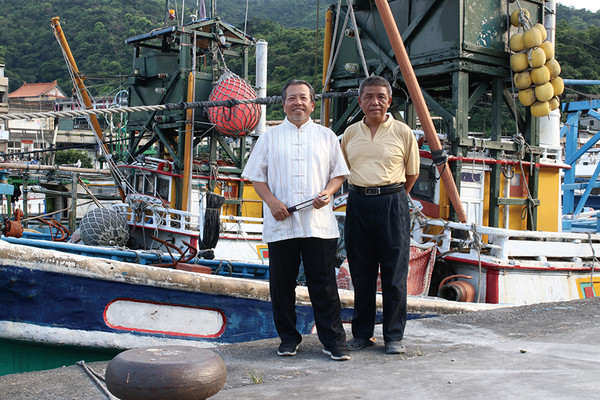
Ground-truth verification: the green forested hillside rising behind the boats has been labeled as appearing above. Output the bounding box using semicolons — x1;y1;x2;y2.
0;0;600;104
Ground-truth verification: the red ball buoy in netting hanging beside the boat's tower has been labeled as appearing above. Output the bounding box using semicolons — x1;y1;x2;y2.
208;71;260;136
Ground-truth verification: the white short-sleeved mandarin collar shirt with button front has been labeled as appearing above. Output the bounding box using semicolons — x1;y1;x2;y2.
242;118;350;243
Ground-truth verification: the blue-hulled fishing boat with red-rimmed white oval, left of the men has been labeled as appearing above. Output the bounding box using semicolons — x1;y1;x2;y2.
0;0;440;373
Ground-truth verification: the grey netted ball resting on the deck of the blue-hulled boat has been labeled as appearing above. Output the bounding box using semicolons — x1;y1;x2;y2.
79;208;129;246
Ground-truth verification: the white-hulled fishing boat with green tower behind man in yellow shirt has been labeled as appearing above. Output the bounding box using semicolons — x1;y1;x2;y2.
321;0;600;304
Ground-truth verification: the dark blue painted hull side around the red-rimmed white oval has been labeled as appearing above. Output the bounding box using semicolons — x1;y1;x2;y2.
0;265;290;343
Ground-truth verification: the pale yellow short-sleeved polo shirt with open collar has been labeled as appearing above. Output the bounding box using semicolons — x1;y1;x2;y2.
342;116;419;187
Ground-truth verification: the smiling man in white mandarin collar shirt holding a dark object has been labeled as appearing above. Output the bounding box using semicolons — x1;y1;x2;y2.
242;80;350;361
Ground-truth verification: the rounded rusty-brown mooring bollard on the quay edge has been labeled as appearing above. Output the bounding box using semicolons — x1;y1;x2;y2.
106;346;227;400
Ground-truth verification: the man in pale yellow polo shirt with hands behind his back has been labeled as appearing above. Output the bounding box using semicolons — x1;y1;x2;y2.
342;76;419;354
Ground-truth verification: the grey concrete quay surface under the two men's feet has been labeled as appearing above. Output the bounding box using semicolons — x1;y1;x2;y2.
0;298;600;400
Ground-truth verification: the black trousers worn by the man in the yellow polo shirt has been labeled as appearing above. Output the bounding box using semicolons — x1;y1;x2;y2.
344;190;410;341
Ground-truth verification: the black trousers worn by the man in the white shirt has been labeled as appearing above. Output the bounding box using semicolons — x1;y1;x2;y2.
269;238;346;347
